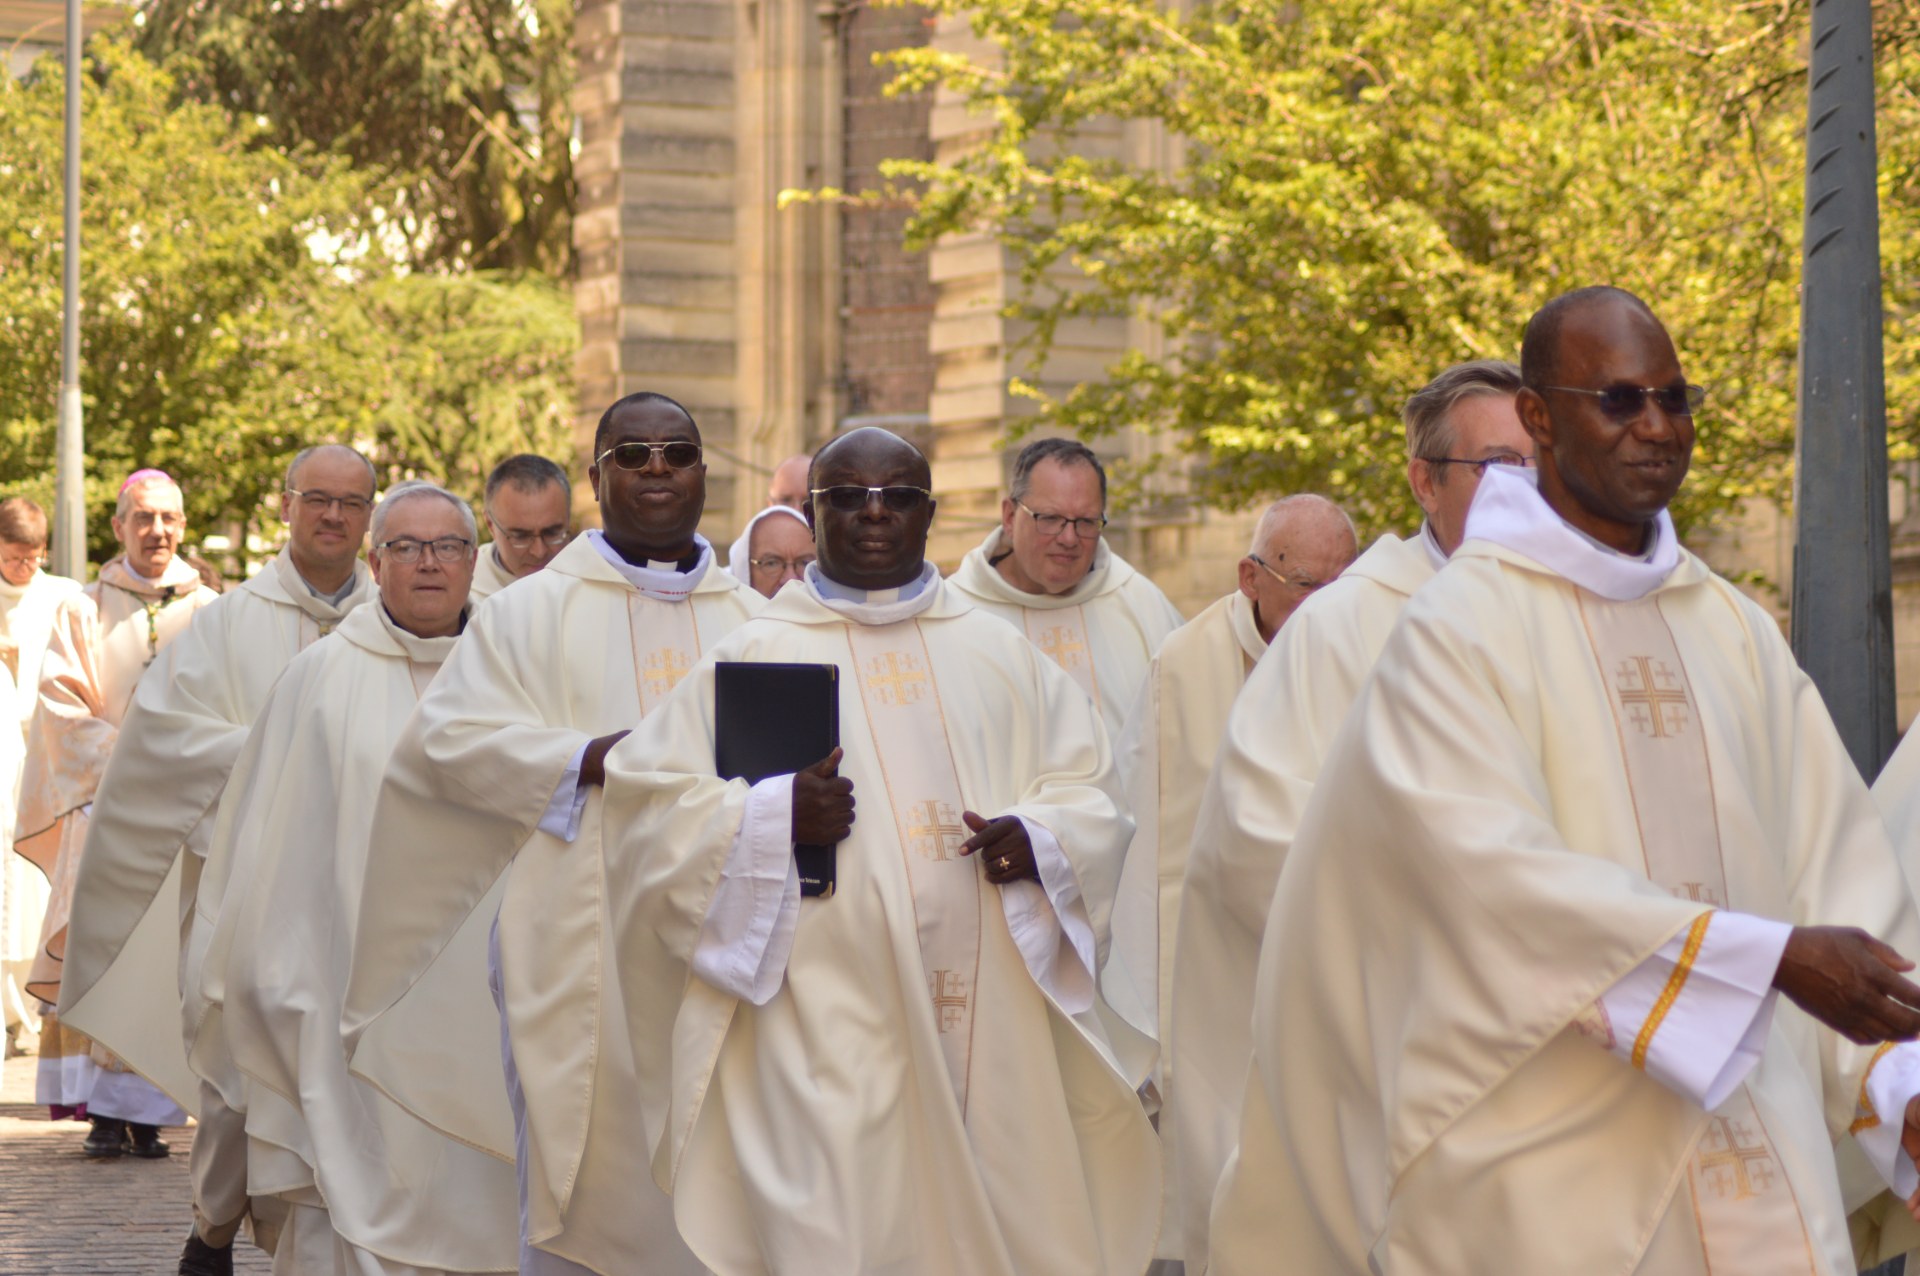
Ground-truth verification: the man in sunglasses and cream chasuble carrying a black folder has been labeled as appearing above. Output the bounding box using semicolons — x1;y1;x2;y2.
607;430;1160;1276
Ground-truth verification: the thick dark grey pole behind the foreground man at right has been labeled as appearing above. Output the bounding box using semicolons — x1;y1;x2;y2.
1793;0;1895;781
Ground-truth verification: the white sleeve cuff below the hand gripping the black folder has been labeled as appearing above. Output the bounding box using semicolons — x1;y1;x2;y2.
693;775;801;1005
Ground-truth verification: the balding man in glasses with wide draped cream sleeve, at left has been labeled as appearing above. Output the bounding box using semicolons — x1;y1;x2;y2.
60;445;374;1276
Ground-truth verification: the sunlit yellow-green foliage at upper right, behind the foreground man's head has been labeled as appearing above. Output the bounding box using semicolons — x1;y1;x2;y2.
887;0;1920;526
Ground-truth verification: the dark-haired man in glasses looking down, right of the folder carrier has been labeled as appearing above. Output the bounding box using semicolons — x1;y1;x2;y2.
948;439;1181;739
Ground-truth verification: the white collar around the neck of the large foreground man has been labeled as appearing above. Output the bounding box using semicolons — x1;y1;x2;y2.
1465;464;1680;603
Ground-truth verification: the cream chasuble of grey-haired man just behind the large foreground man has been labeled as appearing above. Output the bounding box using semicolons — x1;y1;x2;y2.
1160;532;1434;1274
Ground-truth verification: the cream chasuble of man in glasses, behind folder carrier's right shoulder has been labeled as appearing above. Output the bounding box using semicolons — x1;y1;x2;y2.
947;528;1181;739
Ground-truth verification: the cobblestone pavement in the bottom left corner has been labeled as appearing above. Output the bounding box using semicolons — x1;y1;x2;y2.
0;1057;269;1276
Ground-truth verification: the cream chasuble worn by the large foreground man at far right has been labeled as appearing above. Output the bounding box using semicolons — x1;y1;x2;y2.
1210;502;1920;1276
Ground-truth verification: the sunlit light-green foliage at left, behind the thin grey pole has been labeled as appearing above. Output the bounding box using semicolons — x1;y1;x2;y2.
0;40;576;560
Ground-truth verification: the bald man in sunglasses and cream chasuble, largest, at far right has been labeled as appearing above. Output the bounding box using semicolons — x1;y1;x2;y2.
1210;288;1920;1276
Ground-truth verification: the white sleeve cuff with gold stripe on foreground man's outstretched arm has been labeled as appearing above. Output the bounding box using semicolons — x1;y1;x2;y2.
1599;911;1793;1111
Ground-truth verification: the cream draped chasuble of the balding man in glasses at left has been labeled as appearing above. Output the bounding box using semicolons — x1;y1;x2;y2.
60;549;372;1111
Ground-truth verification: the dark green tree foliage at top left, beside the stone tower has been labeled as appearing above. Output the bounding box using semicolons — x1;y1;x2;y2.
136;0;574;278
